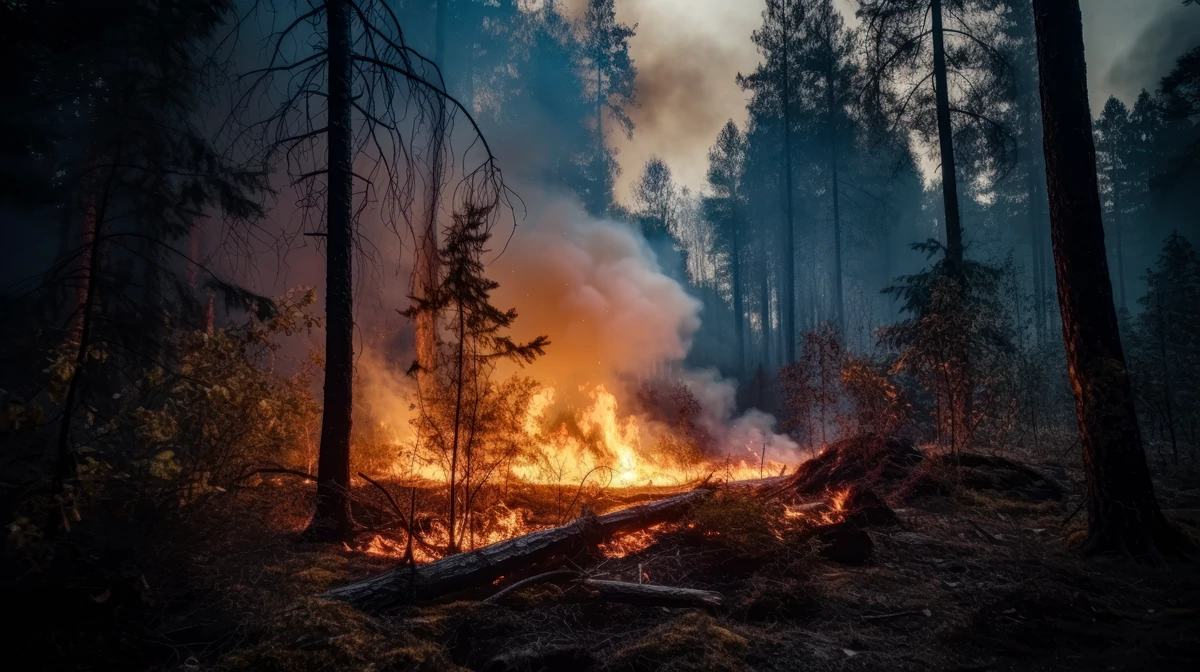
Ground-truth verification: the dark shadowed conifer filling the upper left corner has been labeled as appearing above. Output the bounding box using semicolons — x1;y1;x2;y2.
0;0;265;502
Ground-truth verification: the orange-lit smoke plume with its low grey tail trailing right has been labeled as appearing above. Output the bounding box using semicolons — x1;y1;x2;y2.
488;198;799;462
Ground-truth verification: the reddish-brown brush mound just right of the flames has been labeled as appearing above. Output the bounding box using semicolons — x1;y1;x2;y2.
786;434;924;496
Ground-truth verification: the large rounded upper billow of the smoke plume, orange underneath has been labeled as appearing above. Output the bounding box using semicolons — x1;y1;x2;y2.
488;199;703;389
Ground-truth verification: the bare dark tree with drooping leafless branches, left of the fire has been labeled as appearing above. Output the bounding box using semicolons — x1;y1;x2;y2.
230;0;509;540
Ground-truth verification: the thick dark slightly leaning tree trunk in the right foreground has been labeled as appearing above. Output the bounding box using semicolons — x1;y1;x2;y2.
1033;0;1183;556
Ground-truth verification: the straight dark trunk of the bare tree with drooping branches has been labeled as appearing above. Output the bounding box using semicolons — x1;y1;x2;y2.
305;0;354;541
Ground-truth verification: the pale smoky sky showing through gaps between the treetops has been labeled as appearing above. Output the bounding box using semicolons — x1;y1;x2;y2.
588;0;1200;202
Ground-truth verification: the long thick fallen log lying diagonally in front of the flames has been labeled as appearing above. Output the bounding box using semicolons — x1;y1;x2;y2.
322;488;712;612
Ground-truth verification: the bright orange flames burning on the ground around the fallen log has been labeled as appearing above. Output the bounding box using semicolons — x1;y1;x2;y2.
356;385;794;564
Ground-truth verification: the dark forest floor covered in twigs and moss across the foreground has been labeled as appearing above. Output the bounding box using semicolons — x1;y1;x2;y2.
28;444;1200;672
